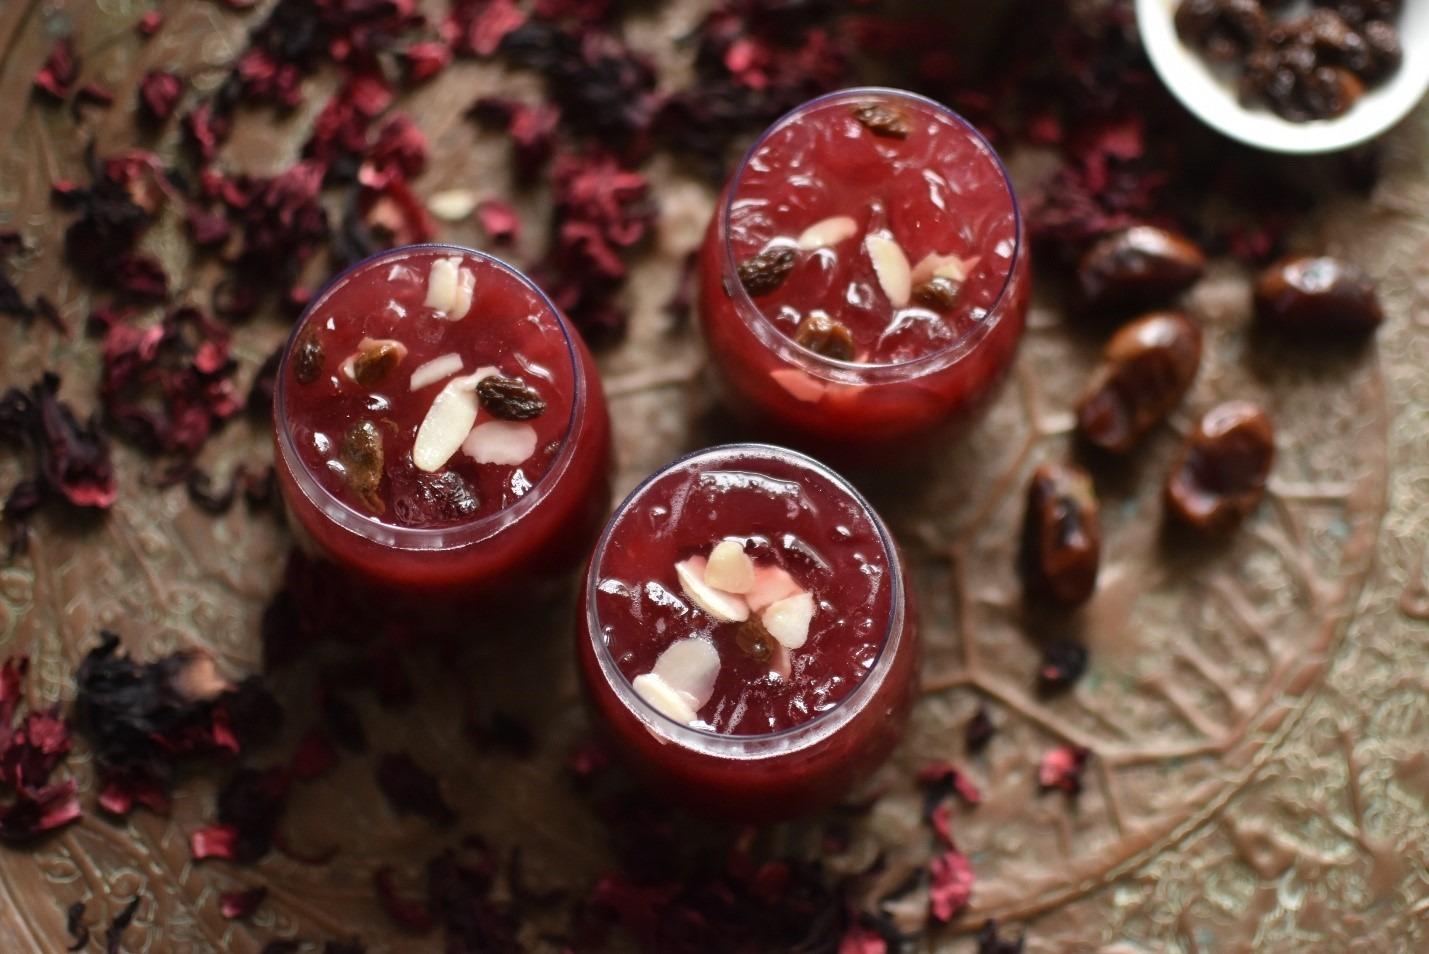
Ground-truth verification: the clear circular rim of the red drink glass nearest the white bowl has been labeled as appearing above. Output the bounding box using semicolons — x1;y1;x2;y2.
715;86;1026;378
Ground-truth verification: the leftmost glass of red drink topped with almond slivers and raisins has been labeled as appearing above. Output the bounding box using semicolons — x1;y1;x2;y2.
274;246;610;604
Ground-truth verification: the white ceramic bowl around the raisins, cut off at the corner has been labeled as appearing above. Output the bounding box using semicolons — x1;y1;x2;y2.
1136;0;1429;154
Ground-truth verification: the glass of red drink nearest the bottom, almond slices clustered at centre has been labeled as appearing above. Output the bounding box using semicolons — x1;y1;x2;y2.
579;444;917;820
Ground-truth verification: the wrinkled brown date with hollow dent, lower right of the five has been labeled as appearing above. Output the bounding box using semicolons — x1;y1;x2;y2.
1166;401;1275;536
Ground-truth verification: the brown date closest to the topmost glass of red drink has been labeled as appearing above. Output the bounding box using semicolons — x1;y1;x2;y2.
1076;226;1206;310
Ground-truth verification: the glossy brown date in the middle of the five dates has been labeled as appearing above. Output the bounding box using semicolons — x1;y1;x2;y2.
1076;311;1200;454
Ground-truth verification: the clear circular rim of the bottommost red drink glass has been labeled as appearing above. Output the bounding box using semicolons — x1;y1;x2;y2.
583;441;907;760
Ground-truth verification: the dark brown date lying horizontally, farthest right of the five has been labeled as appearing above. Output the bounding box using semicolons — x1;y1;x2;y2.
1255;256;1385;336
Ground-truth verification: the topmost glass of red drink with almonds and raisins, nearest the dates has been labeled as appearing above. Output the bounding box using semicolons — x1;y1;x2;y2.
700;89;1029;456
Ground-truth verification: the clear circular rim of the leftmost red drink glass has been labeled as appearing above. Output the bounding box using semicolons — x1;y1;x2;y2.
273;241;589;551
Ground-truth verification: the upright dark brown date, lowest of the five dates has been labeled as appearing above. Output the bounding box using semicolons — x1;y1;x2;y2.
1019;464;1102;606
